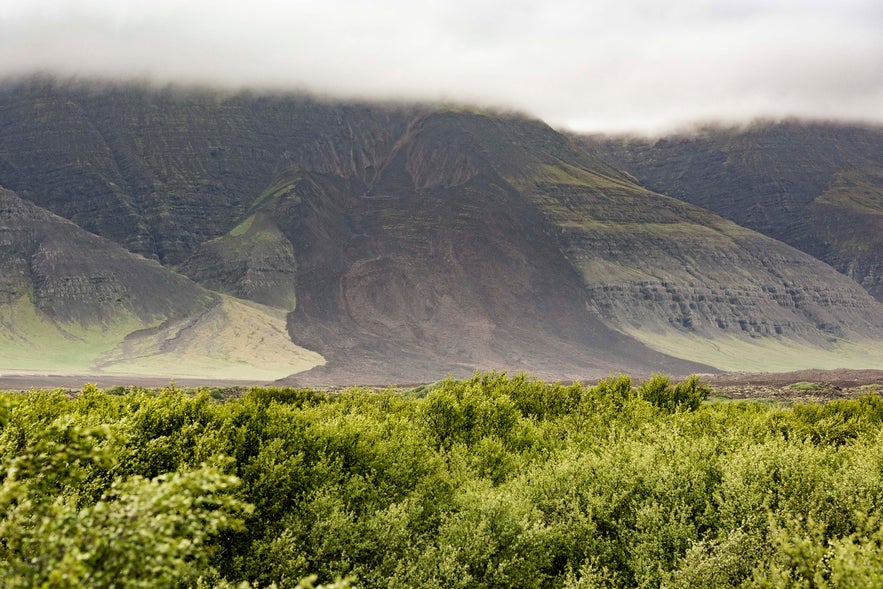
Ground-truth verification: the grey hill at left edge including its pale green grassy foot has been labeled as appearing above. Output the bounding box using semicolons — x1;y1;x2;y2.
0;189;322;380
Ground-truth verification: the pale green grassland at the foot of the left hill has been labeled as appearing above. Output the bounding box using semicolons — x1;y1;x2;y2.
0;297;325;381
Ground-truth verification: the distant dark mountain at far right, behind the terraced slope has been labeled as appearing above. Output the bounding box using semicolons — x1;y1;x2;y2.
577;121;883;300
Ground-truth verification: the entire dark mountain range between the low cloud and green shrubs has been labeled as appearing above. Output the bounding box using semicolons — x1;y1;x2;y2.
0;79;883;384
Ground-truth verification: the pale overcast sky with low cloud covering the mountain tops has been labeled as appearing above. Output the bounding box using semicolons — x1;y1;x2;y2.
0;0;883;132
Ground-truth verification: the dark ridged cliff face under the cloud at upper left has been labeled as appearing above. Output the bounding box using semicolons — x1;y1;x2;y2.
0;80;417;265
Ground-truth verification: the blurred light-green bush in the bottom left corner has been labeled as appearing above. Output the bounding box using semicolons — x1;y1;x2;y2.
0;416;250;587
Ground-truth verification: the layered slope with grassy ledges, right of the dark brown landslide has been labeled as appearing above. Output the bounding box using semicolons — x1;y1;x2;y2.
438;114;883;370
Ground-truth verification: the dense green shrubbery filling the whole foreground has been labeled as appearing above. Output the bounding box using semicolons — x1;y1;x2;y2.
0;374;883;588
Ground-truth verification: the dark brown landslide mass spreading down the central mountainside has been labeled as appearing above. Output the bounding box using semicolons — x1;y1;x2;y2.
274;123;712;382
